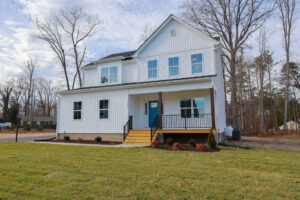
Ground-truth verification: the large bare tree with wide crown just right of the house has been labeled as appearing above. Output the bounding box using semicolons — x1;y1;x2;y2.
182;0;274;128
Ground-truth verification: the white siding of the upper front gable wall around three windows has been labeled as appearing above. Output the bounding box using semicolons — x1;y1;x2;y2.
138;20;215;81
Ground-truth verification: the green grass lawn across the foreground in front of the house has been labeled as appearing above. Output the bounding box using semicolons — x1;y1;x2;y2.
0;143;300;200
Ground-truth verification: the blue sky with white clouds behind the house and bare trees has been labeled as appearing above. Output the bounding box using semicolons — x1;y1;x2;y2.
0;0;300;82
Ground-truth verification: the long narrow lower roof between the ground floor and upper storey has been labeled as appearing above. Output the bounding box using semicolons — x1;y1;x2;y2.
58;74;217;95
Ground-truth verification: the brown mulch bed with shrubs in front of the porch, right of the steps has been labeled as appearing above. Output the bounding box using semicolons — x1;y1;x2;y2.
145;144;221;152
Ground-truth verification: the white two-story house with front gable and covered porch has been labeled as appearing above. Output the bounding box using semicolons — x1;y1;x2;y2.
57;15;225;143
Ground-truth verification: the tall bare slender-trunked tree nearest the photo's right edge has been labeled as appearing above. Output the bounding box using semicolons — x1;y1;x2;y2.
276;0;296;131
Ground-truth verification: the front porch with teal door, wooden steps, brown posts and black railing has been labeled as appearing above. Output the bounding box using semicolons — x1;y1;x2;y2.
123;88;216;143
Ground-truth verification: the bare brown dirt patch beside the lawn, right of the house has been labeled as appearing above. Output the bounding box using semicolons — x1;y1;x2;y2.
229;136;300;151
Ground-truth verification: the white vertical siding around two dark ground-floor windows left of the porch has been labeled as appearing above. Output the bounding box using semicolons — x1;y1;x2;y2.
57;91;128;133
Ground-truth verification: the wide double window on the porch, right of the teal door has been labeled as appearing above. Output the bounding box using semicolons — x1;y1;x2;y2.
180;97;205;118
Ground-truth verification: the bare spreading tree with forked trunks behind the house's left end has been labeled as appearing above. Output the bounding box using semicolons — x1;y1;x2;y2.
32;7;100;90
